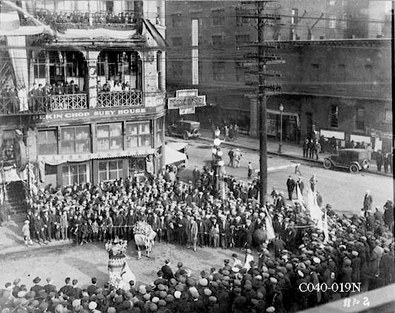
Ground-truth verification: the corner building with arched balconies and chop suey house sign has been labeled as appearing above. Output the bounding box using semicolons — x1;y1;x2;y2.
0;0;166;187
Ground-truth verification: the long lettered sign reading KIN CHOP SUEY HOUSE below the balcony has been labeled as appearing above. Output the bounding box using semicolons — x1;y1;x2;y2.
33;108;147;121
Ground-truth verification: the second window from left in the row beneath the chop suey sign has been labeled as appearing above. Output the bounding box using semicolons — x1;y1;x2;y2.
61;126;91;154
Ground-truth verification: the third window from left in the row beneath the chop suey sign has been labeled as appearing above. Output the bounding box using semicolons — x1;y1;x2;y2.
97;123;122;151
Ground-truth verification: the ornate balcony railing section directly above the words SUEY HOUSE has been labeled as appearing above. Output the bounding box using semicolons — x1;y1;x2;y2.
97;91;143;108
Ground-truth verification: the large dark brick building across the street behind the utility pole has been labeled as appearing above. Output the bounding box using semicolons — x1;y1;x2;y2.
166;0;392;150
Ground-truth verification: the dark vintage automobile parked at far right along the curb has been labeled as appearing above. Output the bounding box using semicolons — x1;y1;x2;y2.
323;149;370;174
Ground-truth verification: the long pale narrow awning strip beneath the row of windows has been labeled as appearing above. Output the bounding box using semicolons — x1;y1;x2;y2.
38;148;155;165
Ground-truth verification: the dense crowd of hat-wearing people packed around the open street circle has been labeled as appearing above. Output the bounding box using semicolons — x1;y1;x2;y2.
10;163;394;313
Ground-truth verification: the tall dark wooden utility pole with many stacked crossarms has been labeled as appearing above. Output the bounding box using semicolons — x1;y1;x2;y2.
242;0;285;205
